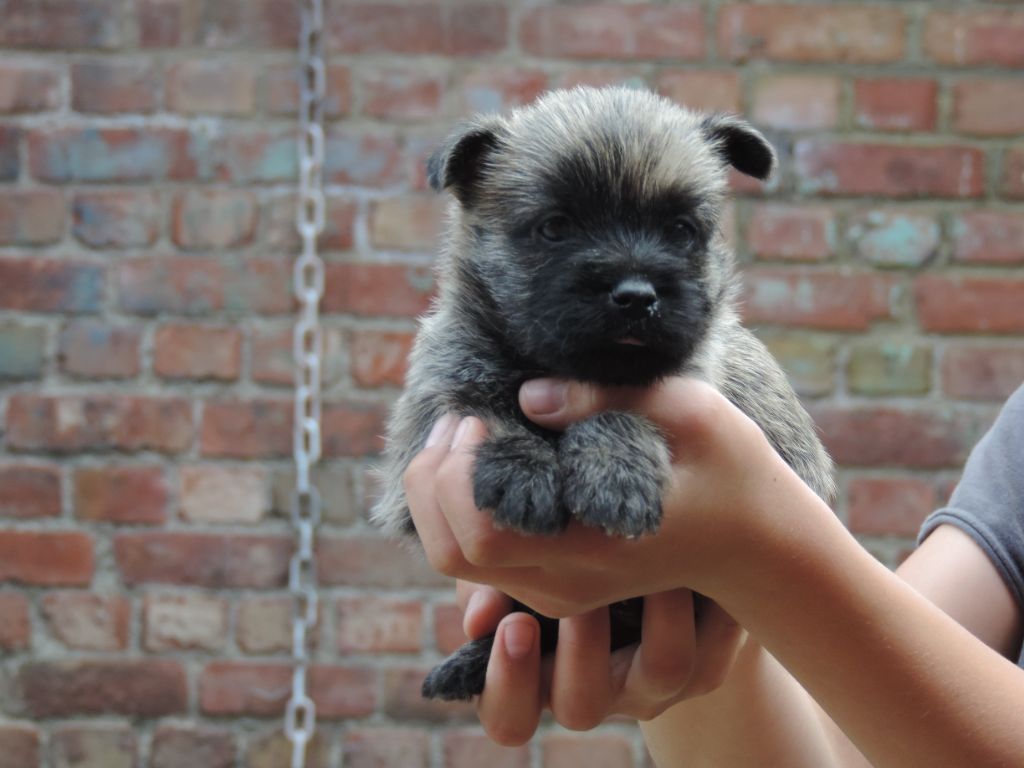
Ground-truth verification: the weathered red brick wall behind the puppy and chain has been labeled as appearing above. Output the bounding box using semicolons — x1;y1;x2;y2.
0;0;1024;768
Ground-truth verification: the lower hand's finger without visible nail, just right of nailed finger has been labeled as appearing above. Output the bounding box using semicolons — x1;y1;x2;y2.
550;606;611;730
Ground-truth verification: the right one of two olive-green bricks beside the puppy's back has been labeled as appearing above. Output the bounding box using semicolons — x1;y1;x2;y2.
846;340;932;395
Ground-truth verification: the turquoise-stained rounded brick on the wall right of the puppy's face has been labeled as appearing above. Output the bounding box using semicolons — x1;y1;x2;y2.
847;206;942;266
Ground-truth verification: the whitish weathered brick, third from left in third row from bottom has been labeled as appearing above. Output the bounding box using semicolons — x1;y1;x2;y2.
142;592;227;653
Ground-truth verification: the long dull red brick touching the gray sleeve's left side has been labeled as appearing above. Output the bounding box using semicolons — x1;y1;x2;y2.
811;406;989;469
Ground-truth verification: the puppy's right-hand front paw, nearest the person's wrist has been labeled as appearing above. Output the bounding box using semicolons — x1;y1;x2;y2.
558;412;670;537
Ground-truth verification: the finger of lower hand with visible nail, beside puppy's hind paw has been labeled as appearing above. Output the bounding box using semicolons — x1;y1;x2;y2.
476;613;542;746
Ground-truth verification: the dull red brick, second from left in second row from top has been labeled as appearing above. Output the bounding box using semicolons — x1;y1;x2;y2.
71;58;160;115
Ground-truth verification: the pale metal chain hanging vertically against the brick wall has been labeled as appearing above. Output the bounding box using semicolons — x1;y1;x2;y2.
285;0;327;768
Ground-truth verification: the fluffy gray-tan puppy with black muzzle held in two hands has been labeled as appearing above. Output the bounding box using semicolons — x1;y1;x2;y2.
374;88;835;699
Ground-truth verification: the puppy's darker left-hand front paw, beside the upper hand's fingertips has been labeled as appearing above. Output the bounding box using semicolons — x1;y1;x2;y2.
473;434;568;534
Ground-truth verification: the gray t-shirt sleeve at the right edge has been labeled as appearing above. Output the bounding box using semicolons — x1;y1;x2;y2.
918;386;1024;667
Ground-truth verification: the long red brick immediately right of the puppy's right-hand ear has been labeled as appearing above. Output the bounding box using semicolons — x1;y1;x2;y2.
795;138;985;198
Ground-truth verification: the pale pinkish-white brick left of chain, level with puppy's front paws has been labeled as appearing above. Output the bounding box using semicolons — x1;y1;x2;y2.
178;464;269;524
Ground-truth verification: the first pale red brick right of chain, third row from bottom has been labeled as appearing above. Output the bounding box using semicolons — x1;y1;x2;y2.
335;595;423;654
